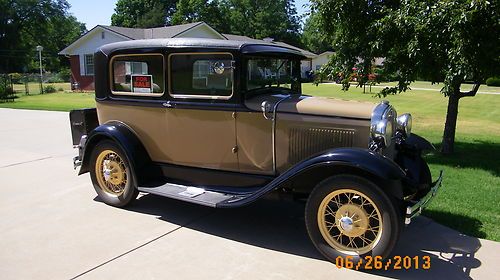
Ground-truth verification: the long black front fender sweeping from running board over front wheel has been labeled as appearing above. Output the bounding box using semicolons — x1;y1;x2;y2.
218;148;406;207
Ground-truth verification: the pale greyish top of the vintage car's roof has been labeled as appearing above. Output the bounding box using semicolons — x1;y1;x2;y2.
97;38;305;58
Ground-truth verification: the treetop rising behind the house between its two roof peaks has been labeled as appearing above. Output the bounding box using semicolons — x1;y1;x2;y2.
111;0;177;28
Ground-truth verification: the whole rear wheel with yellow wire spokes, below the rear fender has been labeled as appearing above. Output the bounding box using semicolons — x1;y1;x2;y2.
90;140;139;207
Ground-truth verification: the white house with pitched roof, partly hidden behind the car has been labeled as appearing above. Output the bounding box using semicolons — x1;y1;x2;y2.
59;22;316;90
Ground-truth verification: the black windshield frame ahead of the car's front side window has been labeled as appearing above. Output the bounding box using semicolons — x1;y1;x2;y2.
241;54;302;96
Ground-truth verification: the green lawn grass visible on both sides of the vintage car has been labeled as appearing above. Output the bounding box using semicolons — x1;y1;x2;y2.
0;82;500;241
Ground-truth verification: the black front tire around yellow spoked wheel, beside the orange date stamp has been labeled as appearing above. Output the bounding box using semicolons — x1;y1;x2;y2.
305;175;402;263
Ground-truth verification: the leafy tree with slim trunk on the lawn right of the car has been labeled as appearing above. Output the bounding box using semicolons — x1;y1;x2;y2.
312;0;500;154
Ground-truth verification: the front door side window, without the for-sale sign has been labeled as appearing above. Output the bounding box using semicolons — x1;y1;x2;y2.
169;53;233;99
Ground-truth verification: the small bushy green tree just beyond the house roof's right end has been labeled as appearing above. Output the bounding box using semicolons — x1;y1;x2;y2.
300;11;332;54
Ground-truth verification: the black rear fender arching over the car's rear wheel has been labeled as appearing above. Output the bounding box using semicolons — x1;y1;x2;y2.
78;122;151;183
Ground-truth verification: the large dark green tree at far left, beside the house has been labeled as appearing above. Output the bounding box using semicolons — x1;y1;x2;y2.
0;0;85;72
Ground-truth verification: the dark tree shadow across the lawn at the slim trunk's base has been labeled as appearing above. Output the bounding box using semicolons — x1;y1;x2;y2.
425;140;500;177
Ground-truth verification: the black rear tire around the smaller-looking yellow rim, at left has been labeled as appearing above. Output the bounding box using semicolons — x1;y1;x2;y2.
90;140;139;207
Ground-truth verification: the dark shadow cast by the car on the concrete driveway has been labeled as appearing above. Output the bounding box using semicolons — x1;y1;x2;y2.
118;195;481;279
